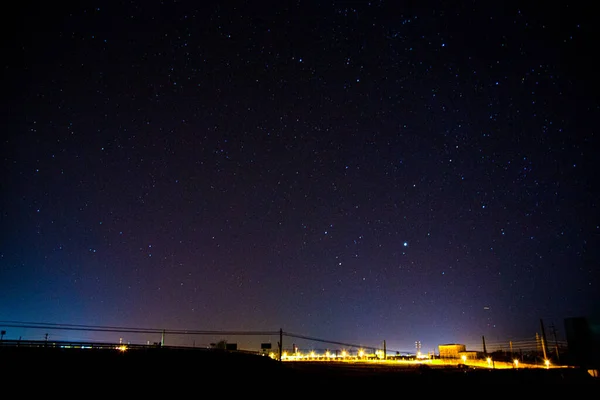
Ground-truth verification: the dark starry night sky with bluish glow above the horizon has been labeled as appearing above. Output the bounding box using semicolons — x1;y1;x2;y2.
0;0;600;350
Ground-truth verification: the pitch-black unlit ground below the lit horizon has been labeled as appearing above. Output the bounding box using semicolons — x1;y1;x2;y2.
0;347;600;395
